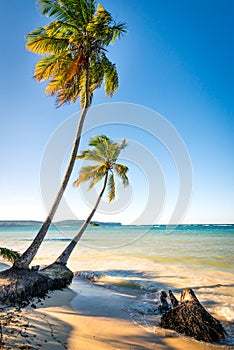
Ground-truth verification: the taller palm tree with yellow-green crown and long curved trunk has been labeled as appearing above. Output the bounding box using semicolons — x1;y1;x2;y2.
14;0;126;269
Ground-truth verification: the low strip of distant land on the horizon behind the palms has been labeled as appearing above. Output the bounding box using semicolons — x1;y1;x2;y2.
0;220;122;227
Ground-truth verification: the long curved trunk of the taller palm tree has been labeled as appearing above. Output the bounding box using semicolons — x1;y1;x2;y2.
13;67;90;269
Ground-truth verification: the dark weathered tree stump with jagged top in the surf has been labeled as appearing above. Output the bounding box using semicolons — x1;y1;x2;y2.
160;289;225;342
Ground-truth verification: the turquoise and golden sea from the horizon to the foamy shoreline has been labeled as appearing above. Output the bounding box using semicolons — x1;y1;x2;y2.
0;225;234;347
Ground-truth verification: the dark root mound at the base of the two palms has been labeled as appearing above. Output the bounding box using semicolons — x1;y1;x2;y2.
0;263;73;304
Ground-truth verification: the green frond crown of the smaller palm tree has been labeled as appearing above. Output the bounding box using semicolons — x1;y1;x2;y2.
74;135;128;202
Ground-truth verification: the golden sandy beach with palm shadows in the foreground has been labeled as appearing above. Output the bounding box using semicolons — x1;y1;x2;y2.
1;278;233;350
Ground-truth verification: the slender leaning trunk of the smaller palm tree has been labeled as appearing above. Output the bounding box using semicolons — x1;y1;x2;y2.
55;173;108;265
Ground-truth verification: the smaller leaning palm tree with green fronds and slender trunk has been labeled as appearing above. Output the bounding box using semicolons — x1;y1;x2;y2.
55;135;128;265
